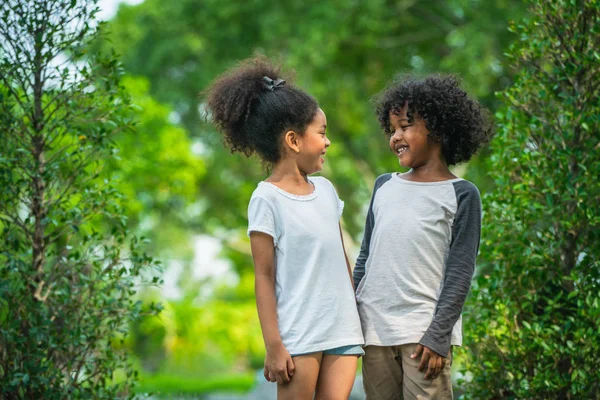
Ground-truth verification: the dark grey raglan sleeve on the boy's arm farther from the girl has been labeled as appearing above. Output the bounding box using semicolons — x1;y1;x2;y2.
419;181;481;357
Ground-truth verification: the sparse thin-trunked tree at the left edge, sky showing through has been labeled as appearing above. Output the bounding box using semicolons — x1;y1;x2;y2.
0;0;155;399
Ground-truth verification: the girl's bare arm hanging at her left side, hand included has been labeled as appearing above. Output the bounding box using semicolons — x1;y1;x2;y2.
250;232;295;383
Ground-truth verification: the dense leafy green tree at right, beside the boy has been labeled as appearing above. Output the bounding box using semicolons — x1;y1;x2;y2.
464;0;600;399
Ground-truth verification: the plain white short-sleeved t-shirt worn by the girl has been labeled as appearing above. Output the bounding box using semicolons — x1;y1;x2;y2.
248;177;364;355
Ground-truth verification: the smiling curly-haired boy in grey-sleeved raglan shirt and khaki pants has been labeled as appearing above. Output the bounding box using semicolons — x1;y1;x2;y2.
354;75;492;400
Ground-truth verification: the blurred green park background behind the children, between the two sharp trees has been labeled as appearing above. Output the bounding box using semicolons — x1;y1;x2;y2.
99;0;527;395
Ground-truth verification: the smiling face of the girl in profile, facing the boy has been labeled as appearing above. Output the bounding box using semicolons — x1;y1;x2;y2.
296;108;331;175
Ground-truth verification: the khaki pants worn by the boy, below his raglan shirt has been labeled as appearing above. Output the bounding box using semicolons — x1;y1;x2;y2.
362;343;453;400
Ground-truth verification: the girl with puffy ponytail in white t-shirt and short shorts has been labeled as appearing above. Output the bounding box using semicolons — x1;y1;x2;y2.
207;58;364;400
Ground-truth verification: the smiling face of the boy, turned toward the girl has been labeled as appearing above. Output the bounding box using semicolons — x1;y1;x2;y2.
390;105;441;169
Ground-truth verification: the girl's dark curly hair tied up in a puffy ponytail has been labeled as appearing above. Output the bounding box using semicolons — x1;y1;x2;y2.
206;57;319;163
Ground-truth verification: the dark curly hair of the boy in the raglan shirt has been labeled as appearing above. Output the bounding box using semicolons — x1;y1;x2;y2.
373;75;493;165
